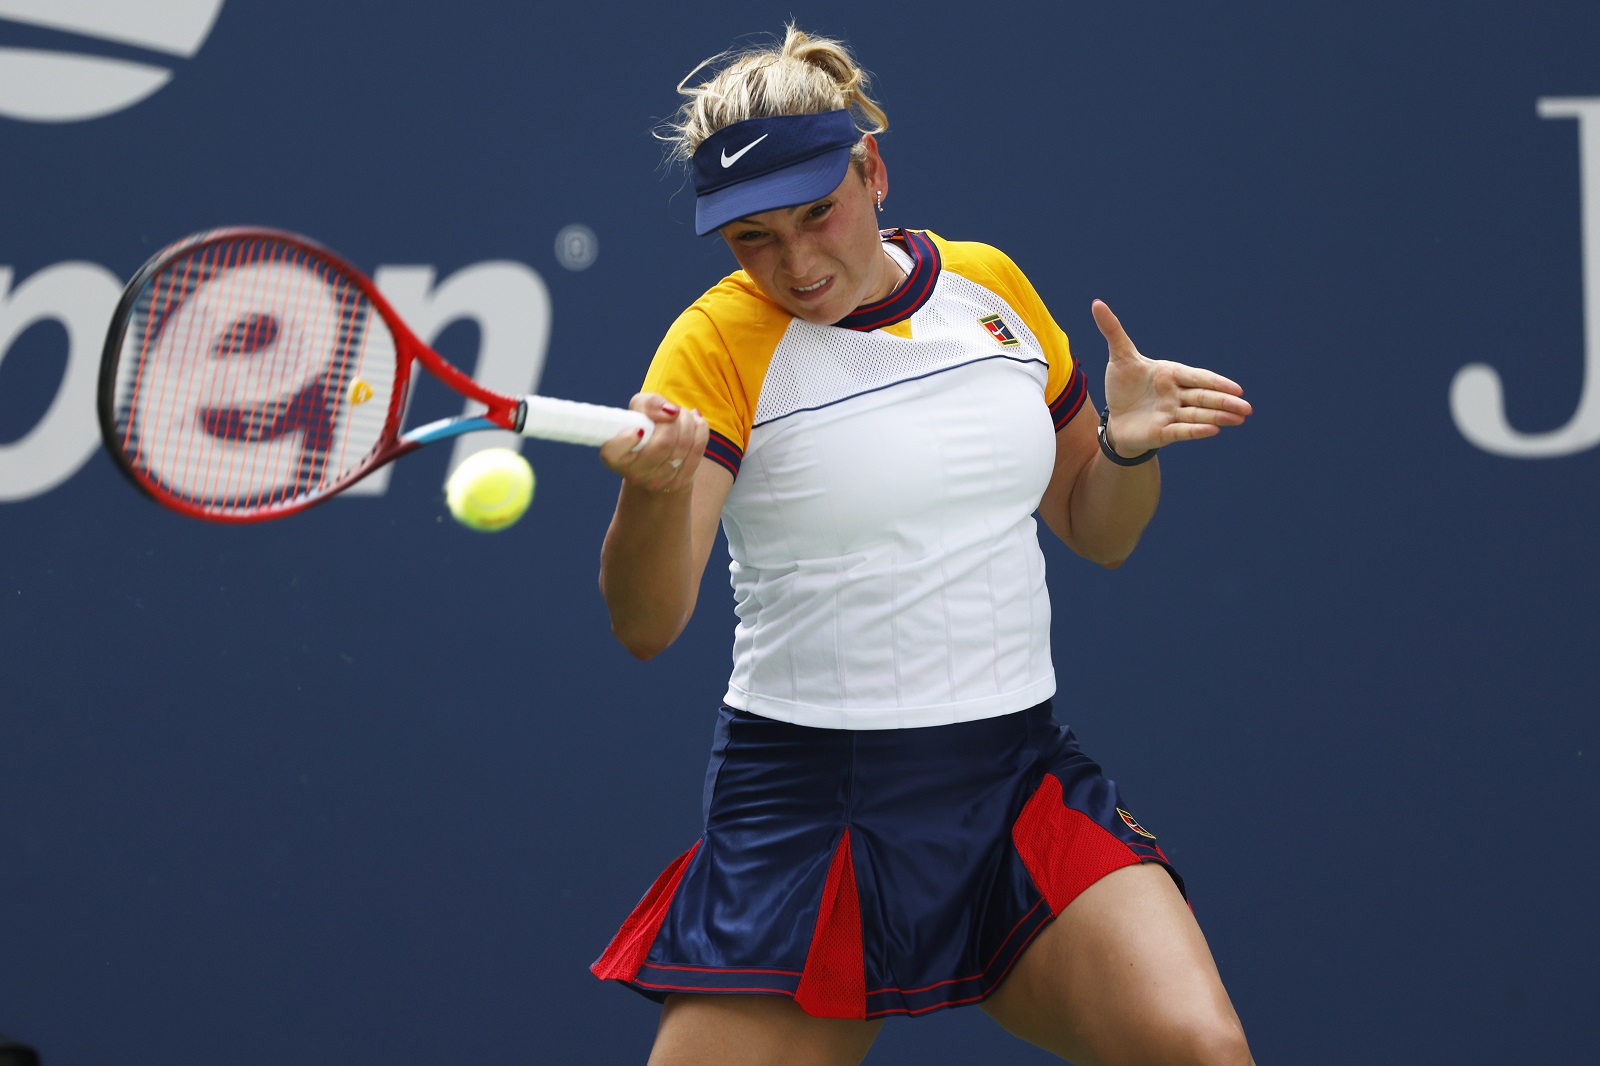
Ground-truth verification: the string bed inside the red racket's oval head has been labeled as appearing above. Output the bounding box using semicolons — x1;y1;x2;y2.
114;238;398;515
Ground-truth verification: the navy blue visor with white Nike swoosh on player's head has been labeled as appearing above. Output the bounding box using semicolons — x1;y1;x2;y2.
694;110;861;237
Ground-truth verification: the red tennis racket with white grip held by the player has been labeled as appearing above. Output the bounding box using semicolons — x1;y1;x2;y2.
98;227;654;522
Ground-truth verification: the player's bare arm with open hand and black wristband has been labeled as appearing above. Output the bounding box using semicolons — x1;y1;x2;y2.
1038;299;1251;568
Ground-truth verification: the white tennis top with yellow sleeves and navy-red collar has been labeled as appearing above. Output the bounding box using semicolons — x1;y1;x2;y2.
645;230;1085;728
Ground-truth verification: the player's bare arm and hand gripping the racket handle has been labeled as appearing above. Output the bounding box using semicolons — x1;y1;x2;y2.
600;394;733;659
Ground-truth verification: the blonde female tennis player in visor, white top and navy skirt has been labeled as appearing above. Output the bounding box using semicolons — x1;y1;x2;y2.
594;26;1251;1066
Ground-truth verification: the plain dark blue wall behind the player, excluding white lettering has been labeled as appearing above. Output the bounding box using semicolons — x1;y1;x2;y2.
0;0;1600;1066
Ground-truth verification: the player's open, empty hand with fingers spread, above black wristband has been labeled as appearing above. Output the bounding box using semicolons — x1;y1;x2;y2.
1093;299;1251;459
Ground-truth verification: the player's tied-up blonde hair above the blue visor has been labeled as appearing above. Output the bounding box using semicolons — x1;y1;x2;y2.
656;22;890;165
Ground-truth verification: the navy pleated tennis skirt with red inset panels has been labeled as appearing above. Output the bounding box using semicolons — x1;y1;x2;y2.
590;701;1182;1018
